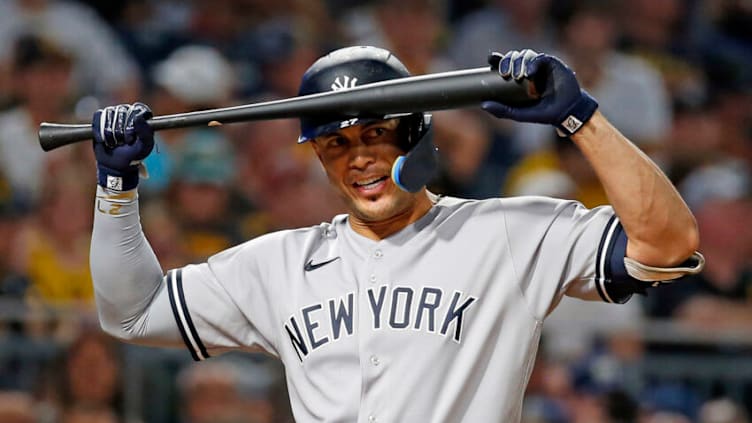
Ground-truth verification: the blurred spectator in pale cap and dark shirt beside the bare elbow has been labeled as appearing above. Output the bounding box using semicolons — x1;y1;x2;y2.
648;161;752;331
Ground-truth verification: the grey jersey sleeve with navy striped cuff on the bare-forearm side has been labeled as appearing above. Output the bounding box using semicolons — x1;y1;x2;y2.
505;197;634;319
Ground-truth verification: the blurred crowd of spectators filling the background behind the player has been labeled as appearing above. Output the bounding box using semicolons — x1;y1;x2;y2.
0;0;752;423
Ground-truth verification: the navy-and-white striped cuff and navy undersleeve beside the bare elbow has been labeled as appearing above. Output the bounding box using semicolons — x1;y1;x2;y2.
595;216;642;304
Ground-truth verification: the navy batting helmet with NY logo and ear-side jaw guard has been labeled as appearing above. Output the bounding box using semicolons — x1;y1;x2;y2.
298;46;437;192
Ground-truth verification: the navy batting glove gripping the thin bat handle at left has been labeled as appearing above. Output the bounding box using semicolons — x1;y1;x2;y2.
91;103;154;191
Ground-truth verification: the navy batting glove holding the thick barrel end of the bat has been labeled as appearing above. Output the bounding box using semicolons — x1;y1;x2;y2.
482;49;598;136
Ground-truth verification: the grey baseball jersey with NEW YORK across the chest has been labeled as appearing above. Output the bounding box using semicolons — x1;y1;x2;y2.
165;197;629;423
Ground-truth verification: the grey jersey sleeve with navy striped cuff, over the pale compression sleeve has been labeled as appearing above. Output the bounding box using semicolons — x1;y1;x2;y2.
165;241;277;361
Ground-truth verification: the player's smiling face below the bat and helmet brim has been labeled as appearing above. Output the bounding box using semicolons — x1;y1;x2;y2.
313;119;416;222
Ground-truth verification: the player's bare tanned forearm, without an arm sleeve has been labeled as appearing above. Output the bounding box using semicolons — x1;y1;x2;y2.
572;112;699;266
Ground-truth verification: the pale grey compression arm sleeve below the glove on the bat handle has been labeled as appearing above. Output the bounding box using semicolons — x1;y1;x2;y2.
90;187;184;347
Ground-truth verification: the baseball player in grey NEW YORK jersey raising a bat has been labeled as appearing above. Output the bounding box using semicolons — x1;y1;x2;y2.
91;47;703;423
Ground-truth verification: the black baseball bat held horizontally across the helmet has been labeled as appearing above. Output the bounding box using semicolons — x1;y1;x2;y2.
39;67;535;151
